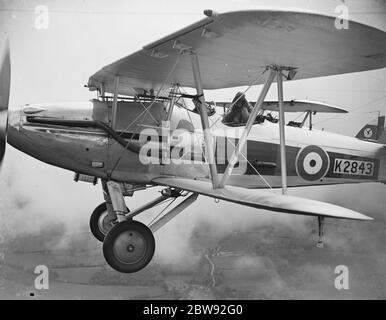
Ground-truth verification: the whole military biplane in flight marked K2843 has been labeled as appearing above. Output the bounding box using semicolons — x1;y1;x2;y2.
0;10;386;273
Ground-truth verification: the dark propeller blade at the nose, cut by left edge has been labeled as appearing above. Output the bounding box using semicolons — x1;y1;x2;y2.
0;41;11;164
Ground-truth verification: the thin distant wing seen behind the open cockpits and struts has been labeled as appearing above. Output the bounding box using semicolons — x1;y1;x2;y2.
210;100;347;113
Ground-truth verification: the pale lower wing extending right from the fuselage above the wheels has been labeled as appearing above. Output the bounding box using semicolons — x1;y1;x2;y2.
153;177;372;220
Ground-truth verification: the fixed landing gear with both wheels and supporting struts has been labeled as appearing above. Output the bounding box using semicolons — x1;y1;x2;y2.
90;181;198;273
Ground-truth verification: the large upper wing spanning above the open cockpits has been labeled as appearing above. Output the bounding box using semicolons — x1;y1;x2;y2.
88;11;386;95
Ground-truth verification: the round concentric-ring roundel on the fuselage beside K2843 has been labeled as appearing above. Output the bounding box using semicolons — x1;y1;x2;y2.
296;146;330;181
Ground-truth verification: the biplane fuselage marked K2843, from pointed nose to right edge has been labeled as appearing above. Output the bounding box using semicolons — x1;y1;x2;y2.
8;100;386;188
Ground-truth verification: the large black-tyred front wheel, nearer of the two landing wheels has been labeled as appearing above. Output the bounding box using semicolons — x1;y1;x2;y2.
103;220;155;273
